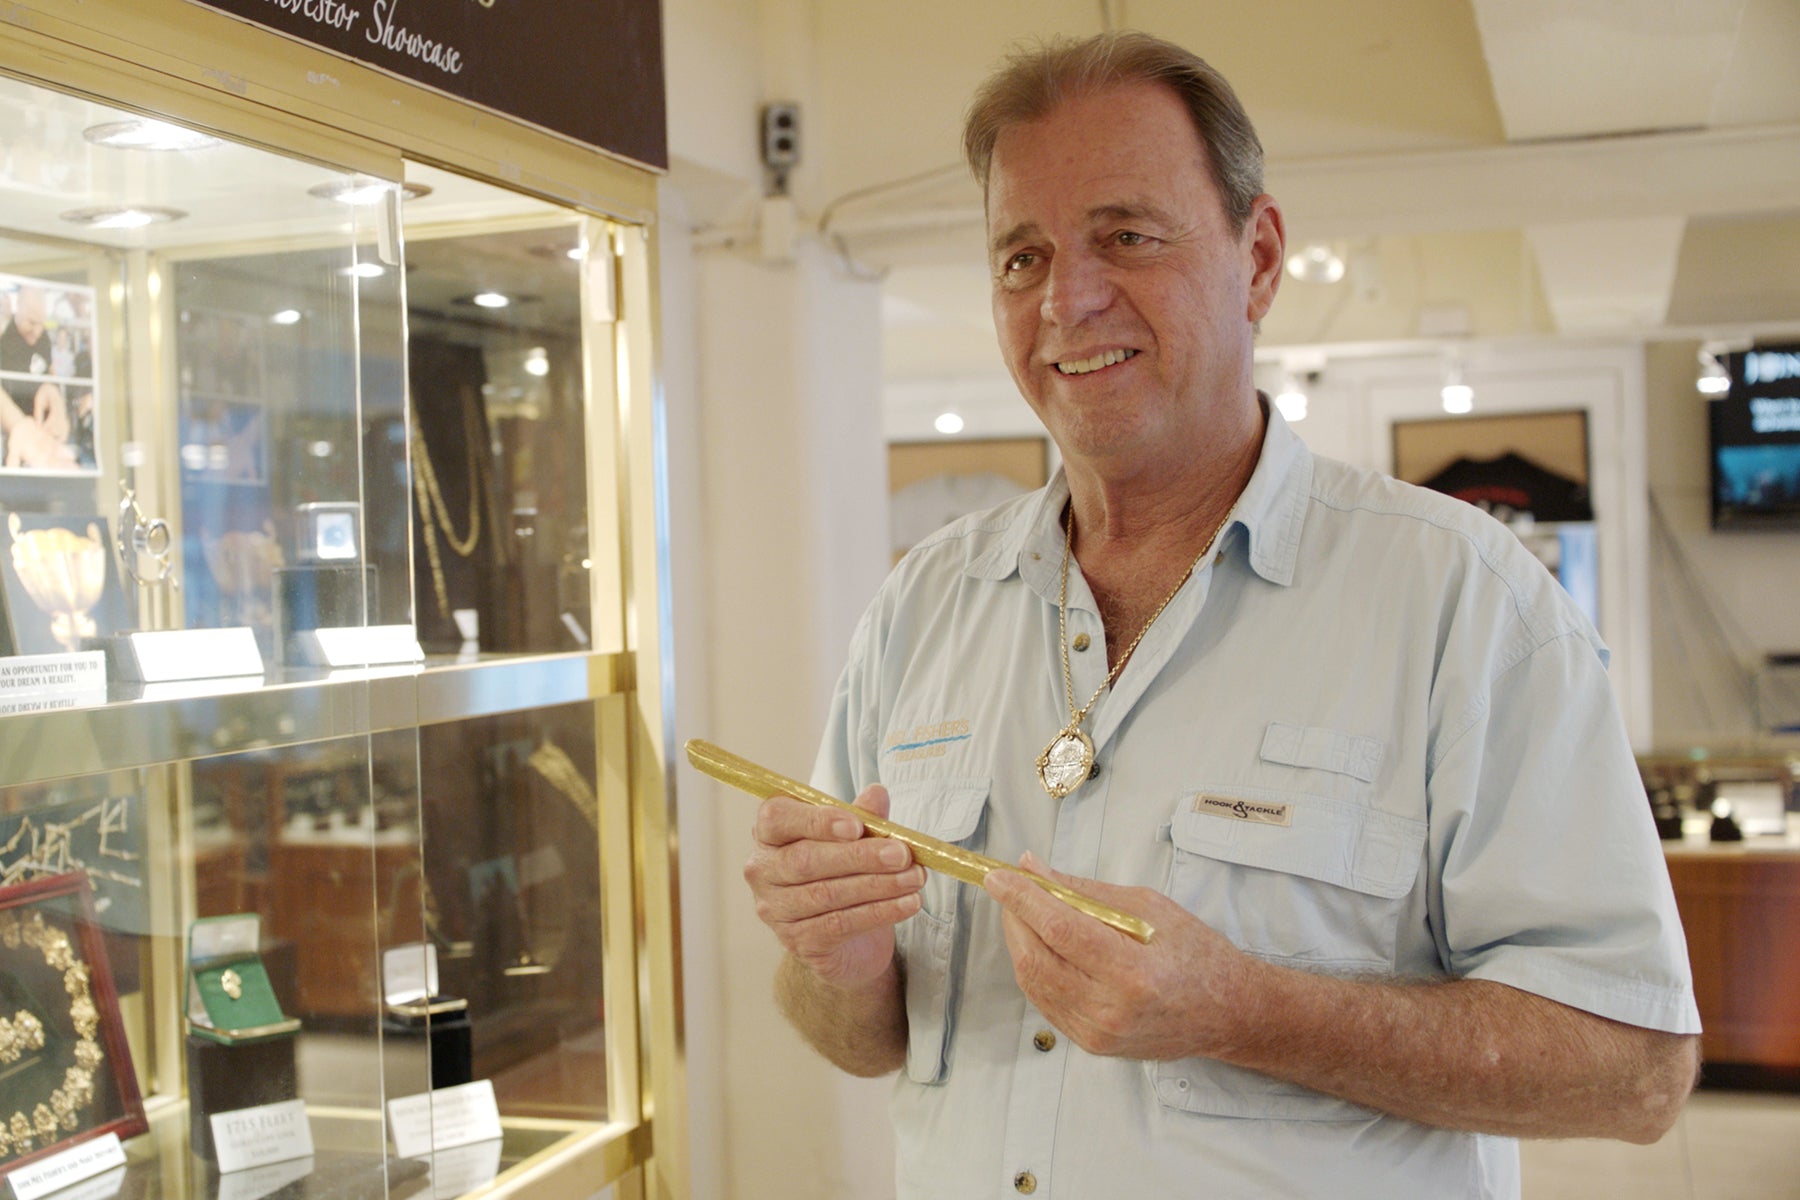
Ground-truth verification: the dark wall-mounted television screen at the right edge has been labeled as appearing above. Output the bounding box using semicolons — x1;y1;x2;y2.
1708;344;1800;529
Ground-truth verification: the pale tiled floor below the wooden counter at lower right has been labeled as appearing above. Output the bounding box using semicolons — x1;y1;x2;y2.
1521;1090;1800;1200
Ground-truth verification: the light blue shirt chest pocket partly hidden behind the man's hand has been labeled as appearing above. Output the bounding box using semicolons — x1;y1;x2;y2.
887;779;992;1083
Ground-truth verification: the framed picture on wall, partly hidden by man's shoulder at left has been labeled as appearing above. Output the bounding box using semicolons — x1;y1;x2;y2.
887;437;1049;561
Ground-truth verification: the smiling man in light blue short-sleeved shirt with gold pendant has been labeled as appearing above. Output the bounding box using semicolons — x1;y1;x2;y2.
745;36;1699;1200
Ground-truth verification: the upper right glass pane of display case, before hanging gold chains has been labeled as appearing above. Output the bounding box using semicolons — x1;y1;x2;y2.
407;197;590;653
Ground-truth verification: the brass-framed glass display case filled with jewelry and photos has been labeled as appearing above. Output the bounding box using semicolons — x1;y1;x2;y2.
0;4;682;1198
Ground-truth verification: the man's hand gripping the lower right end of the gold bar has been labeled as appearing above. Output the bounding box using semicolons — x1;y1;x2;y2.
986;853;1253;1058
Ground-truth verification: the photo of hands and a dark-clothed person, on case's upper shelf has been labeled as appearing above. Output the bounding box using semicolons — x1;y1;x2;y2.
0;273;101;475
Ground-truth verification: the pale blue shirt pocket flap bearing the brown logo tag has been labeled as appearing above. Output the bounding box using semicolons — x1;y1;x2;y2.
1168;788;1426;900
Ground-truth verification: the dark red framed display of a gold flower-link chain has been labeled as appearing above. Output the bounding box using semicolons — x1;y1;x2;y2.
0;873;149;1173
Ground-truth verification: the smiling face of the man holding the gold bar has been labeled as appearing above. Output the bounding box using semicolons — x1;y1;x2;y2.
986;83;1282;464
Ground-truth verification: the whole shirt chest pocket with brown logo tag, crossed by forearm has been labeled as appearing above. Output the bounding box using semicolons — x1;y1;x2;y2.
1145;788;1426;1121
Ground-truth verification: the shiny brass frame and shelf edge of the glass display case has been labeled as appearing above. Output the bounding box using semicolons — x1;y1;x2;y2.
0;0;688;1200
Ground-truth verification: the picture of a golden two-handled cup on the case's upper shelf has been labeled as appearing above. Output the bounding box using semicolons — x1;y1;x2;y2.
0;513;130;655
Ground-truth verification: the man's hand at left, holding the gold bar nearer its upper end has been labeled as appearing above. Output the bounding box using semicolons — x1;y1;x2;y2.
743;784;925;991
